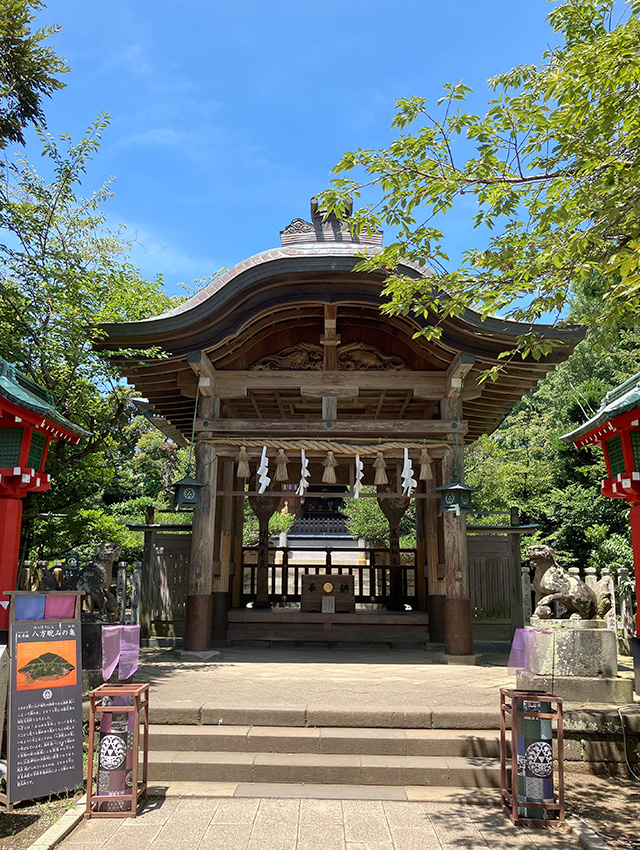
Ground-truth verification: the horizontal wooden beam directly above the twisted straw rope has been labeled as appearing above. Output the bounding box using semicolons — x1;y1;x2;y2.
196;418;468;440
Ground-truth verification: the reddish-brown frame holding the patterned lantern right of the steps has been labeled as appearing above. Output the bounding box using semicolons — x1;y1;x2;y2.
500;688;564;826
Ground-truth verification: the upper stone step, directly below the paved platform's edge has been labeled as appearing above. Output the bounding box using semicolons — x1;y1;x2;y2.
149;725;500;758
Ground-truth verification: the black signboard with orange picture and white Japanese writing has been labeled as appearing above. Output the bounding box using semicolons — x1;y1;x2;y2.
7;620;83;804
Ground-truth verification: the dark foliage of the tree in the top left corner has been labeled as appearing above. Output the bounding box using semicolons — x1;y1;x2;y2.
0;0;69;149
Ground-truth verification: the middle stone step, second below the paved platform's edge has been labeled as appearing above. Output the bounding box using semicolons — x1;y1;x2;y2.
149;750;500;788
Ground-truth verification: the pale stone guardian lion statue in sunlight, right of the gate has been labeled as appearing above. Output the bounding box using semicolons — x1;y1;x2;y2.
527;544;611;620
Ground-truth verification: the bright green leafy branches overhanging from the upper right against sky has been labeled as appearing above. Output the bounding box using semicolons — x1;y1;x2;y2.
321;0;640;357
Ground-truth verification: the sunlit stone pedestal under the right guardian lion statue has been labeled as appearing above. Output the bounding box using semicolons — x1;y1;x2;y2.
517;616;633;705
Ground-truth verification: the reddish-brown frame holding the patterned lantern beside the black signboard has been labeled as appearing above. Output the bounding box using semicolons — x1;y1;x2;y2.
84;684;149;818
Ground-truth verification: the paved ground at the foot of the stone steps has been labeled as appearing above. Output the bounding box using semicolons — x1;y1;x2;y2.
59;798;578;850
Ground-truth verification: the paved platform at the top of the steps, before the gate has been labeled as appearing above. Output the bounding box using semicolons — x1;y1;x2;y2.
136;647;515;711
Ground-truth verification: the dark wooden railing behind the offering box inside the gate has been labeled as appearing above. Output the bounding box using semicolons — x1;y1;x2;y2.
242;546;416;607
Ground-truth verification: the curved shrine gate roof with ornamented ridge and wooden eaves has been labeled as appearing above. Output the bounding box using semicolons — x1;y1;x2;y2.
100;202;584;439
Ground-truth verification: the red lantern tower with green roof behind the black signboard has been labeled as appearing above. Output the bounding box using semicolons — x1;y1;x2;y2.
0;359;88;629
